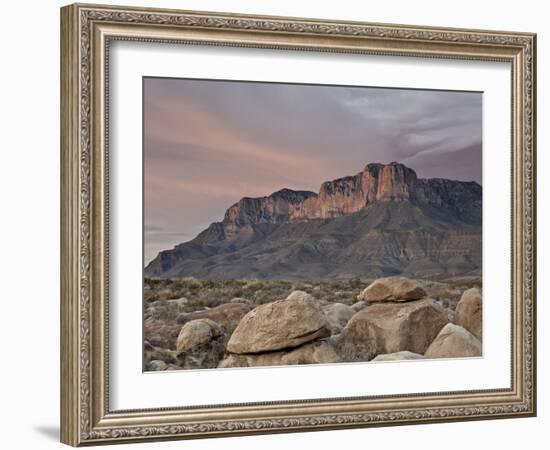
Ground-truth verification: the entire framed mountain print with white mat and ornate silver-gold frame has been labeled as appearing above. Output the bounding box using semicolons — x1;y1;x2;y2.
61;4;536;446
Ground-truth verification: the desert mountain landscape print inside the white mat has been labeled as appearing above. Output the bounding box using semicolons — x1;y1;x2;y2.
144;76;483;372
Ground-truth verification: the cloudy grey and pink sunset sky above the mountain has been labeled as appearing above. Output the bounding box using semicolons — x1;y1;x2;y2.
143;78;482;263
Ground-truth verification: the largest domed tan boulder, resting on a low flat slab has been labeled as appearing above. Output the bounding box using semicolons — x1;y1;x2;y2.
227;291;330;353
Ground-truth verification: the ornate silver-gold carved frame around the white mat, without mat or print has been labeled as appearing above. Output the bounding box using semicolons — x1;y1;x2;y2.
61;4;536;446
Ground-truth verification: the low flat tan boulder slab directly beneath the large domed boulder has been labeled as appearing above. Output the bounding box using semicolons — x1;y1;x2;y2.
218;340;342;368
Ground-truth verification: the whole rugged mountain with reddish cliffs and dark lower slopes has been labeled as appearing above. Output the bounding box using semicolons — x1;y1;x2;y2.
145;162;482;279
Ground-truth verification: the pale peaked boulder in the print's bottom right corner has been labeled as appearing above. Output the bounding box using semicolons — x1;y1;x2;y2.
424;323;481;358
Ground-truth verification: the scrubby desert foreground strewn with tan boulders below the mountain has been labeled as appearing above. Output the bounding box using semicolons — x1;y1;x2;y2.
144;277;482;371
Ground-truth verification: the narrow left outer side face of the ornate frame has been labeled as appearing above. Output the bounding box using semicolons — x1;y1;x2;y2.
60;5;80;446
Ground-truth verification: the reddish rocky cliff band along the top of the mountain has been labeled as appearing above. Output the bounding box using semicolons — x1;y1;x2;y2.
223;162;481;235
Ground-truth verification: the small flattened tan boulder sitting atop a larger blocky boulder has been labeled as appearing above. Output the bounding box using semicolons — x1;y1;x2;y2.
357;277;426;302
